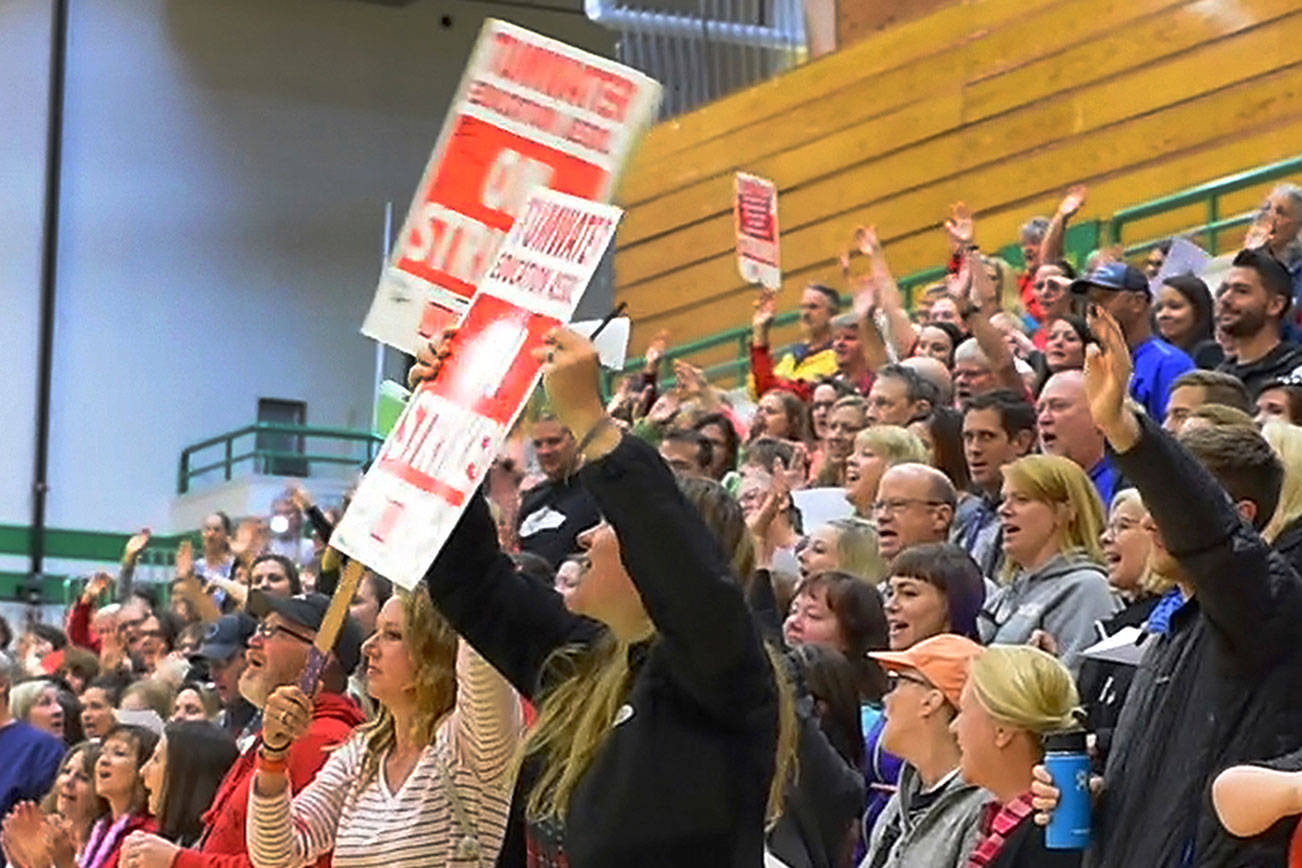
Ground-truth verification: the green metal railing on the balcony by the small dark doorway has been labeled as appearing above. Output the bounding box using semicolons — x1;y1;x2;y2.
177;422;384;495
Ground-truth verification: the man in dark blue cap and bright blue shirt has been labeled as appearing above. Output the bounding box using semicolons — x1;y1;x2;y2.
1072;262;1192;422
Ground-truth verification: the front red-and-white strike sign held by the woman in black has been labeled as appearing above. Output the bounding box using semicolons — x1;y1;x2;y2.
331;190;622;588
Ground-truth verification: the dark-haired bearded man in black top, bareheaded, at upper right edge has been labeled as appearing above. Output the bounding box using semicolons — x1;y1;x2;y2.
1216;249;1302;400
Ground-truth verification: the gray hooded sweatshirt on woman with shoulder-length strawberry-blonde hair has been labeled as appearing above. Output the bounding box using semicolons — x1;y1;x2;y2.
977;552;1121;675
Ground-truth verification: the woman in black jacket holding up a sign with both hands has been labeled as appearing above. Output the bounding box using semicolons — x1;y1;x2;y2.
423;329;793;868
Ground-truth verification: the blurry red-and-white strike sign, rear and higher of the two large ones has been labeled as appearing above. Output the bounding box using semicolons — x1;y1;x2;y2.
362;20;660;354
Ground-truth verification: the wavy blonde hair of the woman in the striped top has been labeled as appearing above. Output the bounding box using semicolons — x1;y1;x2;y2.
350;587;457;796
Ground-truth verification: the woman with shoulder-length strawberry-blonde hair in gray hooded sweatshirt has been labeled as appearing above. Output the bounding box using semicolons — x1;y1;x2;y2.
979;455;1121;673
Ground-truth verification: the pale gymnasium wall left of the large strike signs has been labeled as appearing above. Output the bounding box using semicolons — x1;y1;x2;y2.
0;0;612;538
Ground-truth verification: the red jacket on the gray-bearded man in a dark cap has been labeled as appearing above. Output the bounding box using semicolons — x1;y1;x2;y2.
172;694;365;868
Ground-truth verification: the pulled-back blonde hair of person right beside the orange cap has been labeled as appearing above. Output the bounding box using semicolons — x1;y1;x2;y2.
967;645;1081;735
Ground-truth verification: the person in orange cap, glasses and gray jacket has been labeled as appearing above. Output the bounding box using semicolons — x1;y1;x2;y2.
859;634;986;868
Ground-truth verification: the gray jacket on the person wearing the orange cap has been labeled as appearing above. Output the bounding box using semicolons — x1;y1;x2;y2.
859;764;993;868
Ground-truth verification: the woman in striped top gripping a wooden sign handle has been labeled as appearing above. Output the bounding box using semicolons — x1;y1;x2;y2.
247;590;521;868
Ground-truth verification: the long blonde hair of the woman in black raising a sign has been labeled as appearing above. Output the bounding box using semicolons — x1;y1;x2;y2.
519;631;798;822
